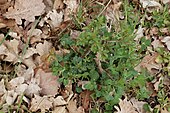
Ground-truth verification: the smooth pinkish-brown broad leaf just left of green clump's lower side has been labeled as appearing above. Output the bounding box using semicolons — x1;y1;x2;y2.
35;69;60;95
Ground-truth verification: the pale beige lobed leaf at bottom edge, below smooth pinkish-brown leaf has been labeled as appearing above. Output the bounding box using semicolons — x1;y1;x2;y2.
30;95;52;112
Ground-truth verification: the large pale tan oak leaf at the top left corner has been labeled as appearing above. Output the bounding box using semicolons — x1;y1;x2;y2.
3;0;45;25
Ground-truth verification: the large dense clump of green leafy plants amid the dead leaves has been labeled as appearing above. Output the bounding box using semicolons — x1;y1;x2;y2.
52;2;149;112
